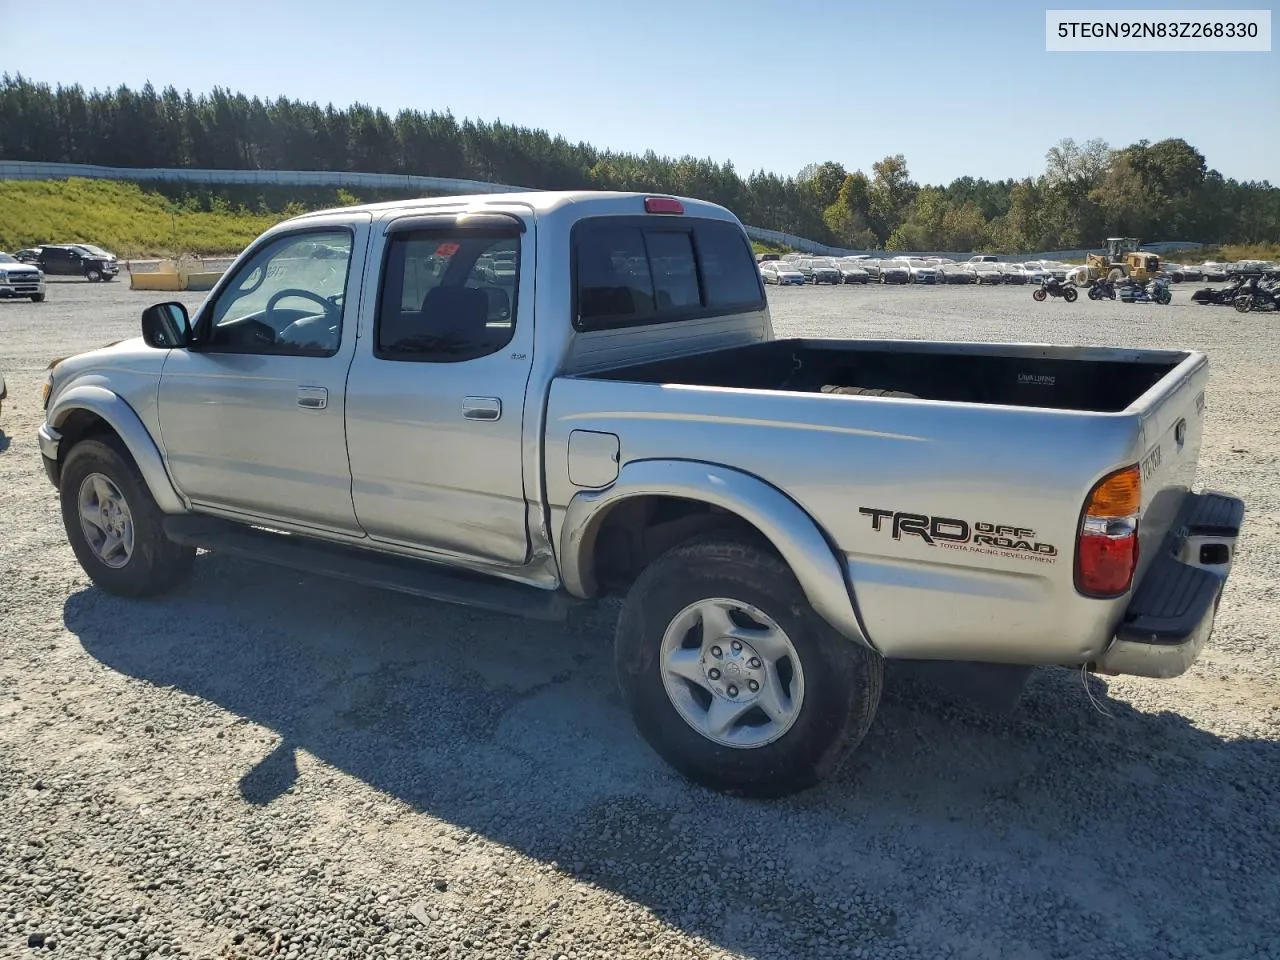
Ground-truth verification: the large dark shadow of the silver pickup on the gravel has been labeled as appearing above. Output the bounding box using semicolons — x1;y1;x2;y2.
64;556;1280;957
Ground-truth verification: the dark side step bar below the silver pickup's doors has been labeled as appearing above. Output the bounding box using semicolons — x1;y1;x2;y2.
164;515;581;621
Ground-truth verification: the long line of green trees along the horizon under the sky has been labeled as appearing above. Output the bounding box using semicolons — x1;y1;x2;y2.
0;73;1280;253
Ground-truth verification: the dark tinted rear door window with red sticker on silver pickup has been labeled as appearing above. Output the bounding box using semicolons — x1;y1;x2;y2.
374;230;520;364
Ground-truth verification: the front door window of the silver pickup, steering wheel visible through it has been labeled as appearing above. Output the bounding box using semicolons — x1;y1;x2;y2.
196;229;352;357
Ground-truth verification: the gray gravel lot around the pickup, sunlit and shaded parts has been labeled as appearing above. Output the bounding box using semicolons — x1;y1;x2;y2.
0;283;1280;960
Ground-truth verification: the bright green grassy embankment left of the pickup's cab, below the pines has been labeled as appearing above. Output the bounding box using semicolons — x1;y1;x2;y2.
0;179;302;257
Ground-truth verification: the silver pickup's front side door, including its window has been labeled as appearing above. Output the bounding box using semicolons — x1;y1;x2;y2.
160;214;371;535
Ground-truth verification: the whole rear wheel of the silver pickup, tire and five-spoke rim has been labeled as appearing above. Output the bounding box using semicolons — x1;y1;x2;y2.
614;539;883;796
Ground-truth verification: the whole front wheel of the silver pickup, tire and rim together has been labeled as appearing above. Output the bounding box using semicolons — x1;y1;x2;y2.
58;436;196;596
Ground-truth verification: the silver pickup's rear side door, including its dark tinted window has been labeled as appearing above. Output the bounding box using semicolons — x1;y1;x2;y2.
347;214;534;566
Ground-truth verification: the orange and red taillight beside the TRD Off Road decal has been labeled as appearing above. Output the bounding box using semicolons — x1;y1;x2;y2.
1075;465;1142;596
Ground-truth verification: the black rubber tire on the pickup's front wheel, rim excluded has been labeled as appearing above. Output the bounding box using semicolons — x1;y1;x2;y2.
58;434;196;596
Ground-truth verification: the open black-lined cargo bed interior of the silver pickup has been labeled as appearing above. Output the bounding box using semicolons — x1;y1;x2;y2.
586;338;1188;413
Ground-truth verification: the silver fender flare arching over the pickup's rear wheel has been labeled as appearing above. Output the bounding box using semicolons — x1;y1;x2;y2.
558;460;870;646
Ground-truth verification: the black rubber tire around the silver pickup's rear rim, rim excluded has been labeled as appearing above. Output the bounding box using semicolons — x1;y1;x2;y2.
614;539;883;797
